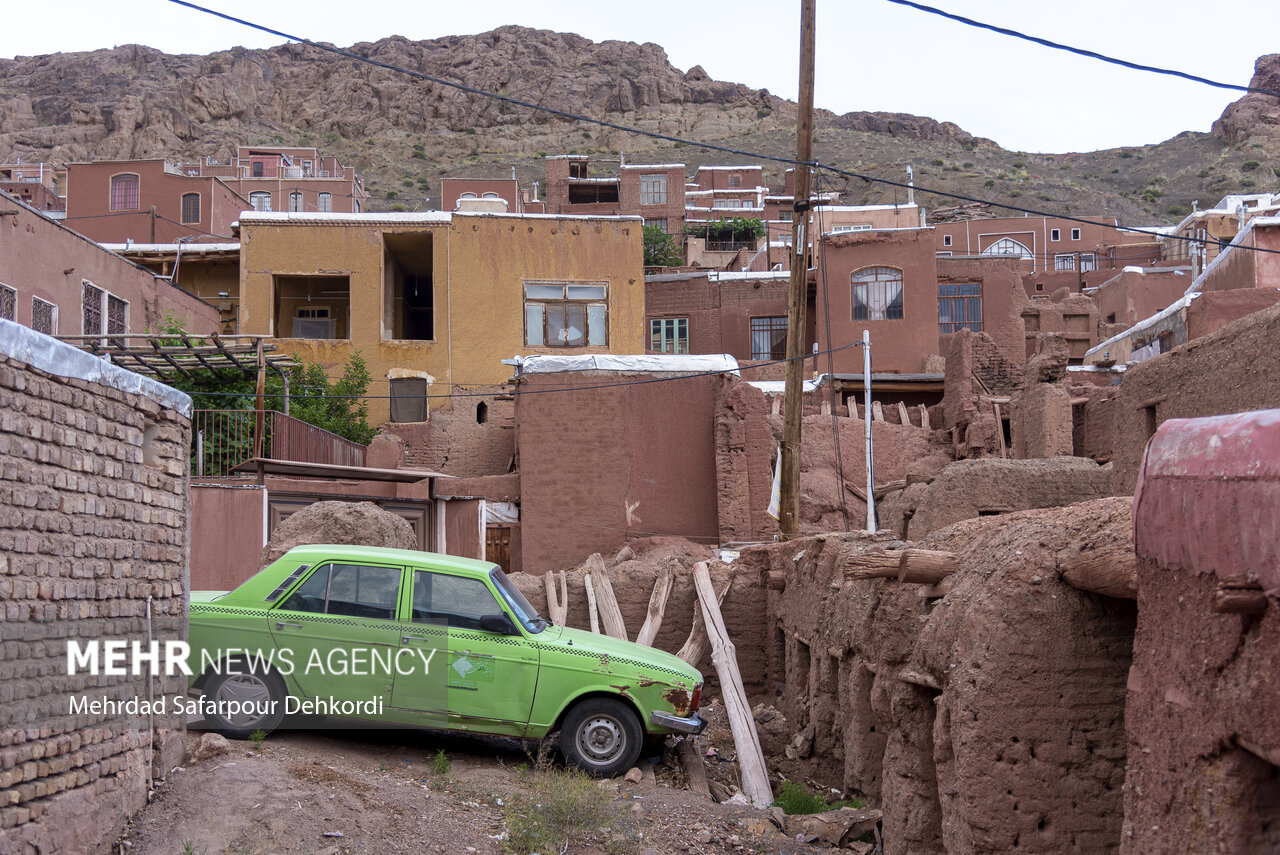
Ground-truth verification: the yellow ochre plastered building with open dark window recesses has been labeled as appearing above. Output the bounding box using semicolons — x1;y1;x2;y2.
239;211;645;424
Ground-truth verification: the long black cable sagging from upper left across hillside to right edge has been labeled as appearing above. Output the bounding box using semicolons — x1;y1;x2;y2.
169;0;1280;261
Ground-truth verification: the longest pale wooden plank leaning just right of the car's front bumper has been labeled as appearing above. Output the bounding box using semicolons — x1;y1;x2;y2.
694;560;768;808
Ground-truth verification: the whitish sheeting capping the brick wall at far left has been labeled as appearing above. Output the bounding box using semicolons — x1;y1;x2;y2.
0;319;191;419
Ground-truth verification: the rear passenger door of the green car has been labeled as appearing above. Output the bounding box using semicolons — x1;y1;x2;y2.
270;561;404;708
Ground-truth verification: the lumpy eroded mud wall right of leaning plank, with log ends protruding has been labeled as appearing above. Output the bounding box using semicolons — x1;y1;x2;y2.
739;499;1137;855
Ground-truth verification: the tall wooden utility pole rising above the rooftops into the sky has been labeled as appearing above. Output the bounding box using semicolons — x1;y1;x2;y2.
778;0;817;538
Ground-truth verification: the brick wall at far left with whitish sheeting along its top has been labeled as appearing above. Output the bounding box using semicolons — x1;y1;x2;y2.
0;321;191;852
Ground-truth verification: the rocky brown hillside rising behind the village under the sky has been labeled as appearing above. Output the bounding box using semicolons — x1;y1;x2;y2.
0;27;1280;221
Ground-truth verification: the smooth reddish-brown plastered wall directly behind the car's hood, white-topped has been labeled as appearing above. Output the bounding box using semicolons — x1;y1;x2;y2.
516;371;723;575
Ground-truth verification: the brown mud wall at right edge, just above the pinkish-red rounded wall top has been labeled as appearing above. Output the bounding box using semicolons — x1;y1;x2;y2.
1112;301;1280;494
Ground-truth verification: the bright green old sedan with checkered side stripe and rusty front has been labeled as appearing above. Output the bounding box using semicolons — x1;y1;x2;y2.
188;545;704;776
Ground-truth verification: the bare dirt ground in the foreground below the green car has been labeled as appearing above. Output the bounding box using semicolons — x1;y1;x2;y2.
116;730;820;855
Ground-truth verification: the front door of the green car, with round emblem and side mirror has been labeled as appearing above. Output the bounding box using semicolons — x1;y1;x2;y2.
392;570;538;735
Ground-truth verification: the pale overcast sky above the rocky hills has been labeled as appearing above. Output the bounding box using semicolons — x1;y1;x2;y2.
0;0;1280;152
